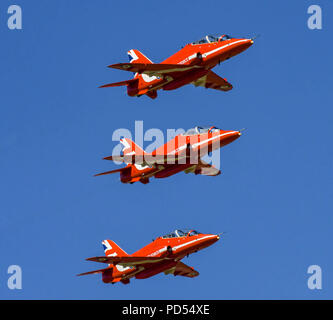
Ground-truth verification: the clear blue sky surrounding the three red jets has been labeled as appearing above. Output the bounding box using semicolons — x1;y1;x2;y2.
0;0;333;299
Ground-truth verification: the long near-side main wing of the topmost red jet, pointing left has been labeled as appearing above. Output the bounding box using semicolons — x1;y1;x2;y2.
109;63;201;77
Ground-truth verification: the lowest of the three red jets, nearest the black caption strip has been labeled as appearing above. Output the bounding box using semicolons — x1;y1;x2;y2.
79;230;220;284
